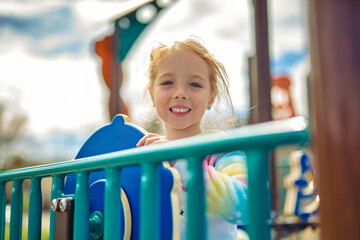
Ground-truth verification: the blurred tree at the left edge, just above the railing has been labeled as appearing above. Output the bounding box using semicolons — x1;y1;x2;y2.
0;100;28;170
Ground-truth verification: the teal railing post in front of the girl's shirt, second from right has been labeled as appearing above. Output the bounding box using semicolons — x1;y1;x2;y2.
186;157;207;240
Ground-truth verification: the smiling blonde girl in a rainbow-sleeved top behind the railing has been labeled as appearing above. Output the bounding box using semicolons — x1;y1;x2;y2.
137;39;247;239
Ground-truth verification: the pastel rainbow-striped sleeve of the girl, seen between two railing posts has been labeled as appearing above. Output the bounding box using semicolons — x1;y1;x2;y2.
204;151;248;225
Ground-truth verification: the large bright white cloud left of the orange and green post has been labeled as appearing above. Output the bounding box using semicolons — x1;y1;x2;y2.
0;47;106;134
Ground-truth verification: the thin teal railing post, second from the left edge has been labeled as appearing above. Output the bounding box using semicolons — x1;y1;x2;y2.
10;180;23;240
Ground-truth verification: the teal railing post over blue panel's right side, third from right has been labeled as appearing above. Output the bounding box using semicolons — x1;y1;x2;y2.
140;163;160;240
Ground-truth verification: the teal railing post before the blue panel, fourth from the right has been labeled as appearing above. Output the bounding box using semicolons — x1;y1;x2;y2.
104;168;122;240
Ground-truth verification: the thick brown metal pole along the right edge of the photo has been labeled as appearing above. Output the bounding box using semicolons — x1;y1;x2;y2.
307;0;360;240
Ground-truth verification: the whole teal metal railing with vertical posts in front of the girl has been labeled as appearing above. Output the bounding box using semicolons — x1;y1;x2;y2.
0;117;309;240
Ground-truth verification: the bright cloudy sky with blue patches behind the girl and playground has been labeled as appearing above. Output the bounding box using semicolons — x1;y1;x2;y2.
0;0;309;163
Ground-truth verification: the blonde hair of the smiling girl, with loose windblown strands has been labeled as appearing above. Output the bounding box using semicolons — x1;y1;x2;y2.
148;38;235;123
